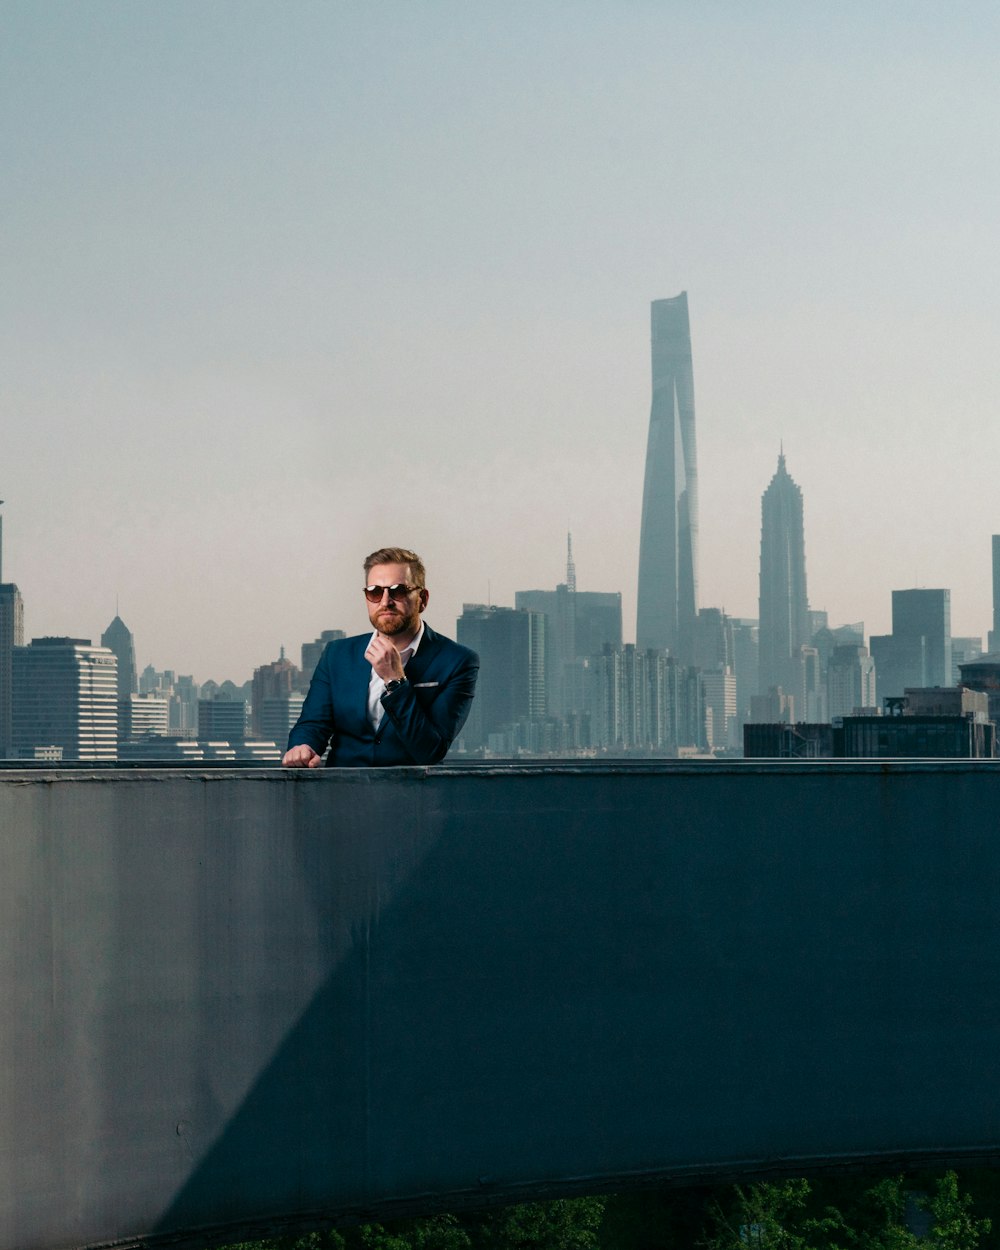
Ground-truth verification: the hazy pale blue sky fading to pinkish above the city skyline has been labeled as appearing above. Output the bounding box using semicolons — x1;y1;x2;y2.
0;0;1000;681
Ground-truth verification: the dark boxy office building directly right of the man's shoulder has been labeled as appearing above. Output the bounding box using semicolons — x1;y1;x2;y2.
455;604;546;751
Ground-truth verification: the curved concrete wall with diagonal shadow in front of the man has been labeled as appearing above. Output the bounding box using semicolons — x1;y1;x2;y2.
0;763;1000;1250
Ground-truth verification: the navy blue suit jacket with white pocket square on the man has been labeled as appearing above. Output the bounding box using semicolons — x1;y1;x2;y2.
289;625;479;768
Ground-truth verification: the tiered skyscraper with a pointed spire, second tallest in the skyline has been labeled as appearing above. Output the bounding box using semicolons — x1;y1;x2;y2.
759;451;810;719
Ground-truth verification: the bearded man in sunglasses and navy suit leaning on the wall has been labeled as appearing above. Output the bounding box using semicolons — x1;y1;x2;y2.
281;548;479;769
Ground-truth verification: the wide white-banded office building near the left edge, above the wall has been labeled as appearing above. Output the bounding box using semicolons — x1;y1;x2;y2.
13;638;118;760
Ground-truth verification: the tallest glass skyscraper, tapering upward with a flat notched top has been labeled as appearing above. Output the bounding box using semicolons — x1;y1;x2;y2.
636;291;698;664
